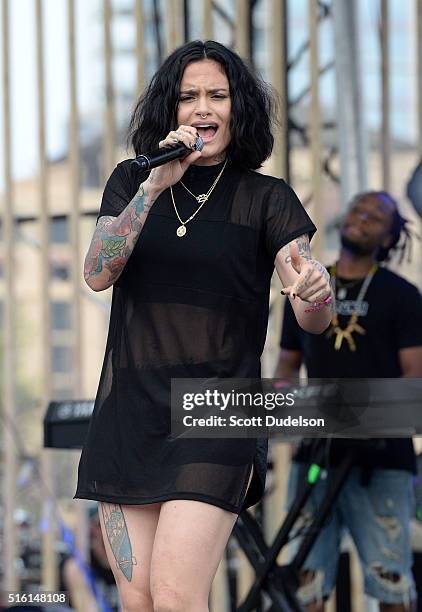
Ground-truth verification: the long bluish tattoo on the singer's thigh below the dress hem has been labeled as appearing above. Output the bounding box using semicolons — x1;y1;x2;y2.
101;502;137;582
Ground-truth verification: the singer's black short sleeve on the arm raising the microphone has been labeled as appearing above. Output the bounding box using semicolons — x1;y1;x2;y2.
97;160;136;221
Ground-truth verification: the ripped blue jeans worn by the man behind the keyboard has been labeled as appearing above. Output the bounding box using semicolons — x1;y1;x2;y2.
288;462;416;605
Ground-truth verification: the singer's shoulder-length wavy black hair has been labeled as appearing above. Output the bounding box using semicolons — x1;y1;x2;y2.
127;40;278;170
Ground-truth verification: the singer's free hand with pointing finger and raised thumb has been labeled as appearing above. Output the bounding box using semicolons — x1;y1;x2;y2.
282;242;331;304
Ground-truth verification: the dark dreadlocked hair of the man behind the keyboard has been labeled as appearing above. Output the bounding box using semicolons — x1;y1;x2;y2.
351;191;413;263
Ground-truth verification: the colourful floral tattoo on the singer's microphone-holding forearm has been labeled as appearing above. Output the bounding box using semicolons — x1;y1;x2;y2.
84;185;154;284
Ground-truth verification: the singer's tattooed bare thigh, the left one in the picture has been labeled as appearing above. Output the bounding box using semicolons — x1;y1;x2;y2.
99;502;161;596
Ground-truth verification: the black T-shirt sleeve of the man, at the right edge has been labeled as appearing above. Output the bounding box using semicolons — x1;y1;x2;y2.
396;283;422;349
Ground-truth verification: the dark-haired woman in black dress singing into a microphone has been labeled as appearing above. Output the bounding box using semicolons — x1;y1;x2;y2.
75;41;331;612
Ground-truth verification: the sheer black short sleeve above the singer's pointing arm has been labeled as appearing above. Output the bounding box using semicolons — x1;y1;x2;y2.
265;179;316;260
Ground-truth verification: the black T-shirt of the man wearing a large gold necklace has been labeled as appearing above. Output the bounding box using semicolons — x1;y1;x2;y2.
280;268;422;472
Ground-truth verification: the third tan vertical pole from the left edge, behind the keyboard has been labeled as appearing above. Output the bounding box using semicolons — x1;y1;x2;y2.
68;0;89;558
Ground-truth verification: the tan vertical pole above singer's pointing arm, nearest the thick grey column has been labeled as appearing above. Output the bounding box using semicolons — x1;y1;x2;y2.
308;0;324;259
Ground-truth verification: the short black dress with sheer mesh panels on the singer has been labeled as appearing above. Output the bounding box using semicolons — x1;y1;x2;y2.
75;160;315;513
